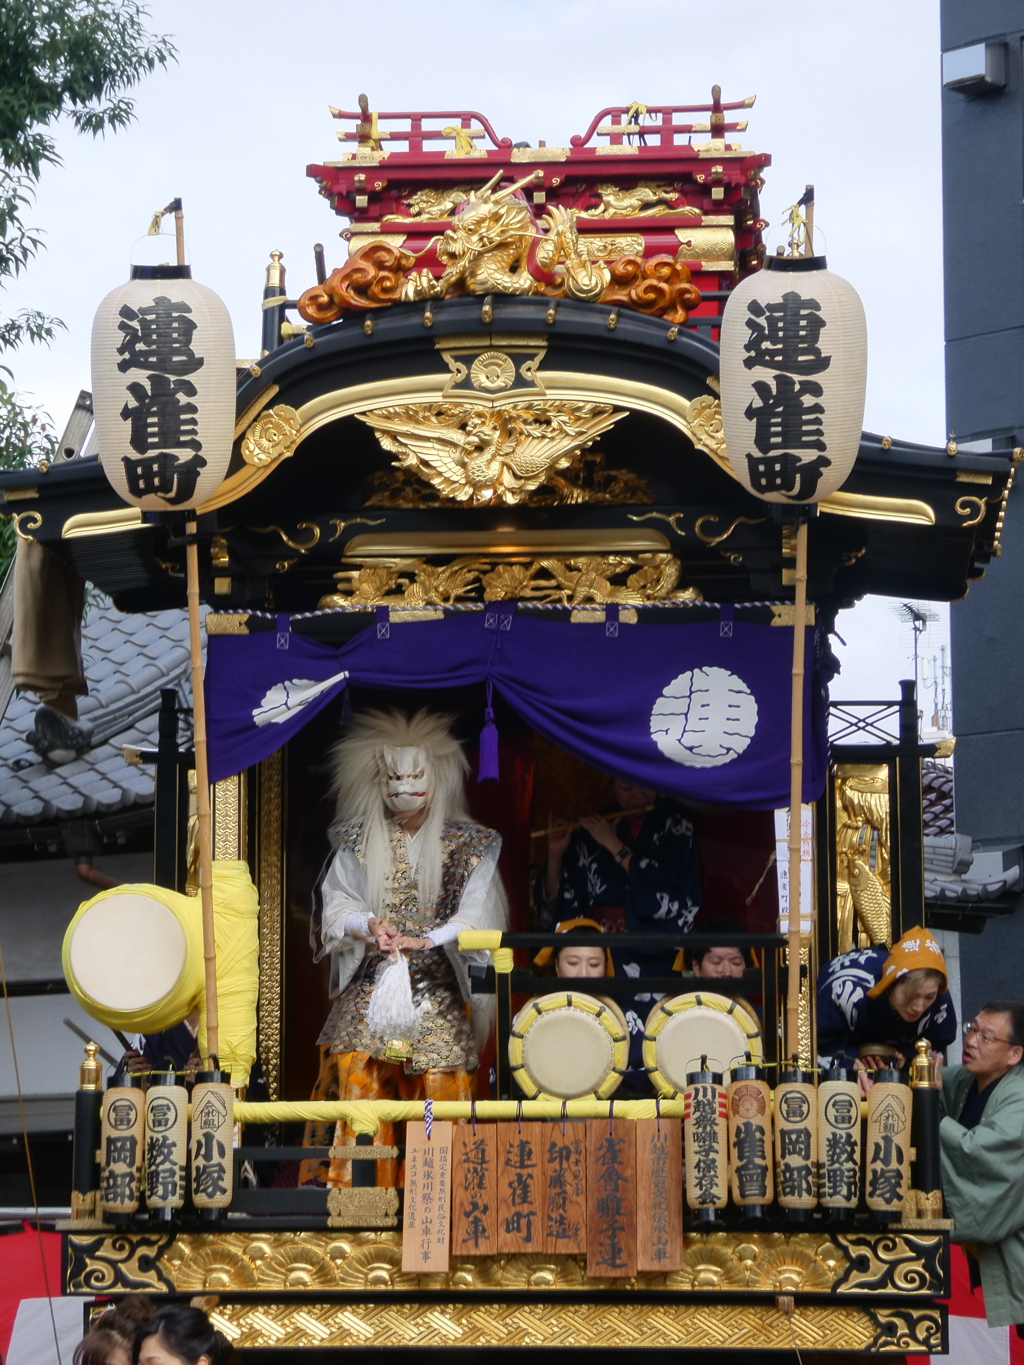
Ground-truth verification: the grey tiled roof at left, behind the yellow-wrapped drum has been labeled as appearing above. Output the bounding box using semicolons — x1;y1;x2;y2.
0;605;190;829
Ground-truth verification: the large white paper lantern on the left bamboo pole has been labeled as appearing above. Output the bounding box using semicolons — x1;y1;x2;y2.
93;265;235;512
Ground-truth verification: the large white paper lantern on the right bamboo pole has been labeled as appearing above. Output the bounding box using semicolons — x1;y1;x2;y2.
721;257;867;502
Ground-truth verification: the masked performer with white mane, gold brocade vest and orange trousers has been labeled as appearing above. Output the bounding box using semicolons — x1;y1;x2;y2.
300;711;507;1185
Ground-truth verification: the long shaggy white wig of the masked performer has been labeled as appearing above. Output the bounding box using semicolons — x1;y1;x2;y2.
332;710;470;915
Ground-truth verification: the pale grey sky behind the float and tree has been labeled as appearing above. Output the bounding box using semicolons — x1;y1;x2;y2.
3;0;946;710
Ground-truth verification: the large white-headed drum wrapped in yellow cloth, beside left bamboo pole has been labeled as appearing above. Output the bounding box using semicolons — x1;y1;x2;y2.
63;886;203;1033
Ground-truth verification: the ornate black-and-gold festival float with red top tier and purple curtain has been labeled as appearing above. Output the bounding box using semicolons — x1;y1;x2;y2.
0;87;1017;1353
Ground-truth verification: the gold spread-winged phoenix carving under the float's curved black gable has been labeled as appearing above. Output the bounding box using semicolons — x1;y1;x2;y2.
358;398;627;506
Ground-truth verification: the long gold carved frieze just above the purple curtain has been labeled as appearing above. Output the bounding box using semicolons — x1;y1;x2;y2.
318;551;702;607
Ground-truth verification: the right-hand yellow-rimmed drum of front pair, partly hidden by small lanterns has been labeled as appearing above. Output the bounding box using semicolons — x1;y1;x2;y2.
643;991;765;1096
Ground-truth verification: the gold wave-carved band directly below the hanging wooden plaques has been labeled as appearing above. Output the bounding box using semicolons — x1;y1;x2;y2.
67;1228;945;1298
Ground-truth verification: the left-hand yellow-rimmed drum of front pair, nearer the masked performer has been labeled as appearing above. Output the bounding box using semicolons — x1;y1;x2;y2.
508;991;629;1100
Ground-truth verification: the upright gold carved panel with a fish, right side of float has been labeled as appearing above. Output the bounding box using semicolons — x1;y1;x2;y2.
836;763;893;953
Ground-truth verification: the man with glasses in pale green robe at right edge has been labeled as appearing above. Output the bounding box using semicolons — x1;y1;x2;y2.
937;1001;1024;1335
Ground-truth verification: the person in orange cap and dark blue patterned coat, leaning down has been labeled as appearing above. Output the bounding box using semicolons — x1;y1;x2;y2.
818;925;957;1089
